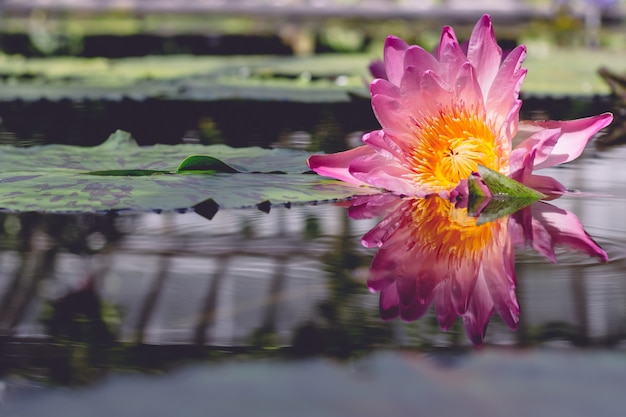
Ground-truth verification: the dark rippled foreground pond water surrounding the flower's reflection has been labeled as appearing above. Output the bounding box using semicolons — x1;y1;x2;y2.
0;99;626;416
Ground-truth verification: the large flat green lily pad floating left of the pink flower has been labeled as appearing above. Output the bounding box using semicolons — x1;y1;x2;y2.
0;131;379;214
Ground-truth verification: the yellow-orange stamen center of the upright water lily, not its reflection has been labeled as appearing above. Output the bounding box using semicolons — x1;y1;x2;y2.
410;105;508;193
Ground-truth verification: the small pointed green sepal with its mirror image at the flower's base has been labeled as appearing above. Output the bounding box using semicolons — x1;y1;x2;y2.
468;165;545;224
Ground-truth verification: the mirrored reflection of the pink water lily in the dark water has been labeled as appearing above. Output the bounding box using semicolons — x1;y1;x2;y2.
348;194;607;345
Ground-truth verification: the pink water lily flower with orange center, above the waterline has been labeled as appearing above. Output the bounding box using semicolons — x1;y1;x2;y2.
308;15;613;197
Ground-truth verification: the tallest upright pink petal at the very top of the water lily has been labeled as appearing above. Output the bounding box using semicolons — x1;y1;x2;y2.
467;15;502;96
